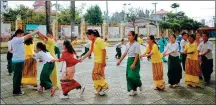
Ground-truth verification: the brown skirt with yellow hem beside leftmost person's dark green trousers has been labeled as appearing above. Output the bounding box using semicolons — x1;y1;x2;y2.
22;58;37;86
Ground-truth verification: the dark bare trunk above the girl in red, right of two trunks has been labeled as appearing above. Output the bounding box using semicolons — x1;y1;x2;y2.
70;1;75;41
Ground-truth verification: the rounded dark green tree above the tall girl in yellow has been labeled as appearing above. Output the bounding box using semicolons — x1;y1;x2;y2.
84;5;103;25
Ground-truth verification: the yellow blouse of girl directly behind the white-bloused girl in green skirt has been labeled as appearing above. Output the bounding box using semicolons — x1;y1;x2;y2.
145;44;162;63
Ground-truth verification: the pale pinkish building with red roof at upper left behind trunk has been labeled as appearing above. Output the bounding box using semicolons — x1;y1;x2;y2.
33;1;56;14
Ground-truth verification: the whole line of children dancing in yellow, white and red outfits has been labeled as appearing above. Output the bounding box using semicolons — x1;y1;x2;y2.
8;29;213;98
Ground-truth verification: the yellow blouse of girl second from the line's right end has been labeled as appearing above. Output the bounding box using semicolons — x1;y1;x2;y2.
184;42;198;60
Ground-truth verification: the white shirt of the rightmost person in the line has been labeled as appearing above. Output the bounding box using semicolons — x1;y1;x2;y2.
198;41;213;59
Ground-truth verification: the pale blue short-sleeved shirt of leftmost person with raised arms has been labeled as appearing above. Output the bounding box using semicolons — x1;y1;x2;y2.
11;37;25;62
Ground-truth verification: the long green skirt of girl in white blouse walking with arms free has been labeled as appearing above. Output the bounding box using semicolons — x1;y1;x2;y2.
126;57;142;91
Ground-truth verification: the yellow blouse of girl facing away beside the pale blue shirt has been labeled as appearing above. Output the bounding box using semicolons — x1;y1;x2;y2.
24;44;35;59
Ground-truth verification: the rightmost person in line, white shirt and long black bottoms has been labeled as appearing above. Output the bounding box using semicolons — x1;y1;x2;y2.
198;33;213;85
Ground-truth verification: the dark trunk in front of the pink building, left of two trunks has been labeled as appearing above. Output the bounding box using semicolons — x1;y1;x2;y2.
45;1;51;34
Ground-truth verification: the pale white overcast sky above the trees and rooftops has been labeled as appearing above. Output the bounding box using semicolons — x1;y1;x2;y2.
5;1;215;26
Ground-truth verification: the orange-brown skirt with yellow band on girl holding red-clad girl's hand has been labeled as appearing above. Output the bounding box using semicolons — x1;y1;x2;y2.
92;63;109;92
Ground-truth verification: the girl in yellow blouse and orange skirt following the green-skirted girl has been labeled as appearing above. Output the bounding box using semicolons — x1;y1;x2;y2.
141;35;165;90
